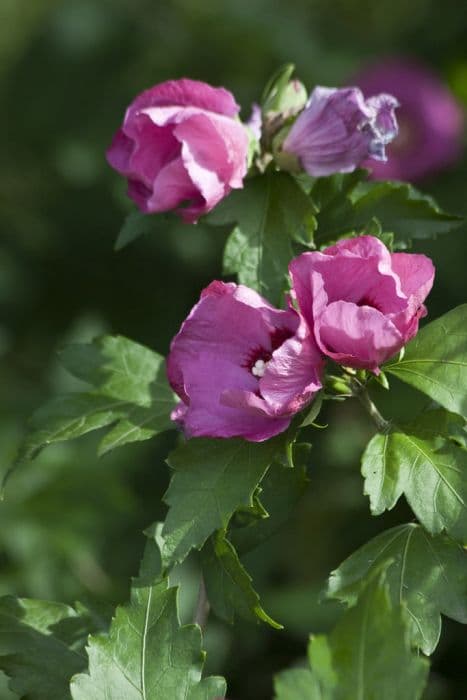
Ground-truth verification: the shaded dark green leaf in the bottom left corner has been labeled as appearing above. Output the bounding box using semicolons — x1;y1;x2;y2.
0;596;96;700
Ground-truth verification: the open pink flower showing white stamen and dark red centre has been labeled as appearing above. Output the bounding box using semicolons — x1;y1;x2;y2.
167;281;323;442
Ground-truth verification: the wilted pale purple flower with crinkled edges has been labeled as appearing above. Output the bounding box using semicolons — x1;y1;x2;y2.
282;87;398;177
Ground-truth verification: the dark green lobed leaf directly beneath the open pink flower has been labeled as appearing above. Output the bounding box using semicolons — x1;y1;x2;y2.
163;436;284;562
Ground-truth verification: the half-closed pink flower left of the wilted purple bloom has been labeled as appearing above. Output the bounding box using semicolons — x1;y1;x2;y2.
107;79;248;222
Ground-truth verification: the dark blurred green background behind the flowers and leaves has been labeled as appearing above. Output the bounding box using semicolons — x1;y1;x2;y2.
0;0;467;700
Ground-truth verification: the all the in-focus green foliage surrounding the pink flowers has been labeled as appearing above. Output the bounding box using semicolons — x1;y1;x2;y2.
0;69;467;700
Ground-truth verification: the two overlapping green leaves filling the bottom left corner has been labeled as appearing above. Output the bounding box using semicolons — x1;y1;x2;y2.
0;533;225;700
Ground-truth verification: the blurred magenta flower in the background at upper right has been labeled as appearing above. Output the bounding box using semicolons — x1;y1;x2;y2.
356;59;463;181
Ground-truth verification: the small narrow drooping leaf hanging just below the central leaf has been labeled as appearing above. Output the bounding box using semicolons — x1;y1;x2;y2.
201;530;283;629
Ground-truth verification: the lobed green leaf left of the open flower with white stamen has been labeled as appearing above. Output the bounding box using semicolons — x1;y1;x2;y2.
18;336;175;461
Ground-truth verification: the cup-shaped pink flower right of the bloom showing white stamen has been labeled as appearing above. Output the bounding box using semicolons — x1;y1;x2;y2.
289;236;435;374
